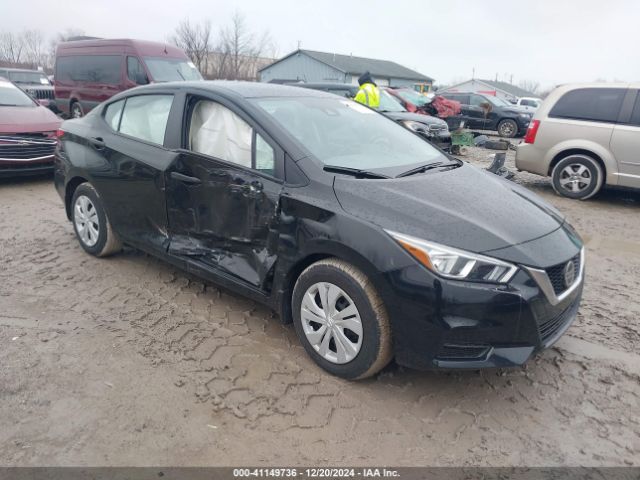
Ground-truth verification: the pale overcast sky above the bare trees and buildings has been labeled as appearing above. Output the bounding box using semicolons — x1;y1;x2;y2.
5;0;640;87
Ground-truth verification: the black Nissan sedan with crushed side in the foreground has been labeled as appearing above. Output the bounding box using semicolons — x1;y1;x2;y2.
55;82;584;379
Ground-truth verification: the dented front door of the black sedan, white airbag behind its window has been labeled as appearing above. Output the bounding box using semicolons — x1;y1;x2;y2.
167;96;283;290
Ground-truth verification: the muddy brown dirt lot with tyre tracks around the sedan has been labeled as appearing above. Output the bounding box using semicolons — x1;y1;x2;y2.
0;145;640;466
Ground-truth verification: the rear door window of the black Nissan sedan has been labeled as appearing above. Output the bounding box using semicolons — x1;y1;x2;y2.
119;95;173;145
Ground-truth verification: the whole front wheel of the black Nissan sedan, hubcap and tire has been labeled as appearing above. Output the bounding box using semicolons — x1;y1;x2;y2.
292;259;392;379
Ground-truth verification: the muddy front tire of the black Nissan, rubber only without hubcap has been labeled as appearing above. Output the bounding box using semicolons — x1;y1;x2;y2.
291;258;393;380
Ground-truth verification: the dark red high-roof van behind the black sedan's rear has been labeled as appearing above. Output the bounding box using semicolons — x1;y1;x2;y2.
54;39;202;118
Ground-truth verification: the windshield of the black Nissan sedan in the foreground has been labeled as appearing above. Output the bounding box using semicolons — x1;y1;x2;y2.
251;97;444;170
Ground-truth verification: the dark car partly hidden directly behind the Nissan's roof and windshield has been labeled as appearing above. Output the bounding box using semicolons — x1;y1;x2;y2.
291;83;451;150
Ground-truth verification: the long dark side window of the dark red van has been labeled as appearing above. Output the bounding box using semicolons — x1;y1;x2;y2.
56;55;122;85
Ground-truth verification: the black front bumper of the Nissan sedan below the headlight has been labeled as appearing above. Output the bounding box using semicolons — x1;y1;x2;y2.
386;246;584;369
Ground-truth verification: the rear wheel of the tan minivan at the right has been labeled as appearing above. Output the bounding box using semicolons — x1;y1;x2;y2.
551;154;604;200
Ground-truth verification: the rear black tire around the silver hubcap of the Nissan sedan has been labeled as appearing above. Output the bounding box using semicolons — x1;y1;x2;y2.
71;183;122;257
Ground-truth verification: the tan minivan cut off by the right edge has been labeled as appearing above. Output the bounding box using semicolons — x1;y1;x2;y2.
516;83;640;200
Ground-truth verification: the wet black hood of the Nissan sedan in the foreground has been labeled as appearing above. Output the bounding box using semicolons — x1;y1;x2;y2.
334;164;564;253
